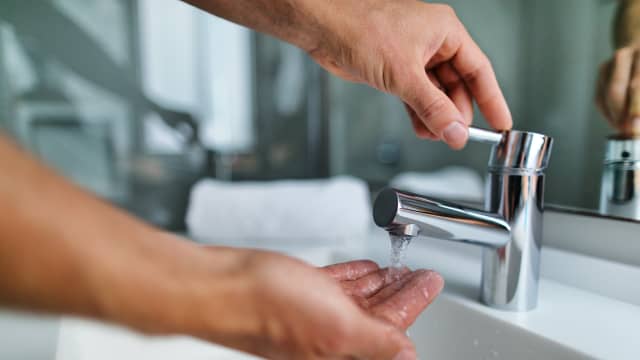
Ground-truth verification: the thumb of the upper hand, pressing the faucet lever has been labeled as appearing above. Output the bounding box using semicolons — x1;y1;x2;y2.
401;72;469;149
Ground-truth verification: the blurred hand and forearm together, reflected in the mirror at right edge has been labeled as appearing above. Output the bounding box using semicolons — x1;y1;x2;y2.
596;0;640;137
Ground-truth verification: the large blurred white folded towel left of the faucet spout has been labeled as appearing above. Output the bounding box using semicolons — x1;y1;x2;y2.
186;177;371;246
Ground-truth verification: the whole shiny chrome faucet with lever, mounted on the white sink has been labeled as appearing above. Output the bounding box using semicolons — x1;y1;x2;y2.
373;128;553;311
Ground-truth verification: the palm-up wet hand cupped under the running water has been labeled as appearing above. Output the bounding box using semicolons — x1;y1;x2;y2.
175;248;443;359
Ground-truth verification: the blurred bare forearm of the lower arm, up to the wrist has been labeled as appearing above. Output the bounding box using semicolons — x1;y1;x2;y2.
0;133;232;333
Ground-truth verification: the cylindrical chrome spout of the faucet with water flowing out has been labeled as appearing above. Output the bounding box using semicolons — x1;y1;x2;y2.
373;188;511;248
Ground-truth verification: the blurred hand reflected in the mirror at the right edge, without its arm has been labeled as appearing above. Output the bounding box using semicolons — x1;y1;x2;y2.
596;45;640;136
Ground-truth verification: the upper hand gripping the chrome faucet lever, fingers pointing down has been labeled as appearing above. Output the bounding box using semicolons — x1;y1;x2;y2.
310;0;512;149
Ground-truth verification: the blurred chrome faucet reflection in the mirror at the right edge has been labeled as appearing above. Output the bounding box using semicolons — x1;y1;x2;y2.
600;137;640;220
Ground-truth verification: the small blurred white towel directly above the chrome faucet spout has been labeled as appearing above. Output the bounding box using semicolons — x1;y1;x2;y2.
390;166;484;202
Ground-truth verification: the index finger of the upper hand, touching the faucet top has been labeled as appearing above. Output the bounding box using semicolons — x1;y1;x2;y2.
451;31;513;130
